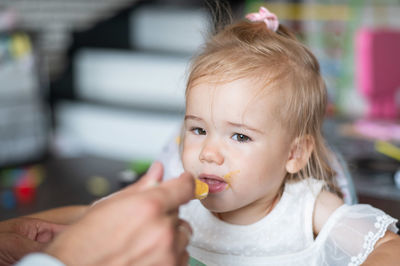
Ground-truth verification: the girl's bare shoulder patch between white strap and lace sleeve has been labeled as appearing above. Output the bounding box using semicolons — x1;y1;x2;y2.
313;190;344;235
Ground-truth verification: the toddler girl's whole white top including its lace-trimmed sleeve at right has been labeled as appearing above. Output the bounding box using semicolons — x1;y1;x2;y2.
180;178;397;266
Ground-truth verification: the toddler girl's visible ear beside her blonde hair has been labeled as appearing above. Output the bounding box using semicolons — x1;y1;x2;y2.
286;135;314;174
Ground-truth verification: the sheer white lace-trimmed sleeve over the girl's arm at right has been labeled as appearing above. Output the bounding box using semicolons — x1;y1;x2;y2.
320;204;398;266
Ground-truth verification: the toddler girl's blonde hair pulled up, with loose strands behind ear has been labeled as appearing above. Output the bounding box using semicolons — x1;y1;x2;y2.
186;21;341;195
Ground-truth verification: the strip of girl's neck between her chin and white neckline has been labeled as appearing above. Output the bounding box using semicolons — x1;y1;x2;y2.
213;193;281;225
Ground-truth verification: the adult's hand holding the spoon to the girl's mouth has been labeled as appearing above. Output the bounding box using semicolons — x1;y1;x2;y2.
45;162;194;265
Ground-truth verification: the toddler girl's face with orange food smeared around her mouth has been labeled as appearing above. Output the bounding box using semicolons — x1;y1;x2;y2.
182;79;291;224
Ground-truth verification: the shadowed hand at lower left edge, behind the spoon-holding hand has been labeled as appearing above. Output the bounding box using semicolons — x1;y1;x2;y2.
0;217;64;265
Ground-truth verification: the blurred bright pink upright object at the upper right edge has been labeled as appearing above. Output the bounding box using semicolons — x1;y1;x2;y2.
355;29;400;119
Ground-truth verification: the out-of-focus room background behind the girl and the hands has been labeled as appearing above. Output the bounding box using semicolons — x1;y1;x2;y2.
0;0;400;220
